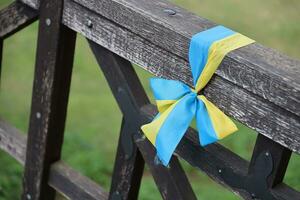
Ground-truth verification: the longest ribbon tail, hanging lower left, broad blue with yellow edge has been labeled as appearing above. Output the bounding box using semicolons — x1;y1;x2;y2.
142;93;196;166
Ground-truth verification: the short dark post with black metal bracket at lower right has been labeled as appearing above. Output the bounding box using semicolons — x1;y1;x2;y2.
218;135;294;200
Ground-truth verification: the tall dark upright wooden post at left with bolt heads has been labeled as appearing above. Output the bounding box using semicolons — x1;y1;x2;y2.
22;0;76;200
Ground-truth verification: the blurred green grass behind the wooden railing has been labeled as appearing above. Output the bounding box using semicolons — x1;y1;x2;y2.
0;0;300;200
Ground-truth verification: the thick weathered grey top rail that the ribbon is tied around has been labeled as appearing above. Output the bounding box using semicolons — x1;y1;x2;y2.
18;0;300;153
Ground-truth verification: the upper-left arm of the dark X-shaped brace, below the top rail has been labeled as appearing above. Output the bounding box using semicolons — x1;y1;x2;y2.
89;41;149;116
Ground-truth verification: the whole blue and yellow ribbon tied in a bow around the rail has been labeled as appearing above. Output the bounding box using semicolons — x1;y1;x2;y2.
141;26;254;166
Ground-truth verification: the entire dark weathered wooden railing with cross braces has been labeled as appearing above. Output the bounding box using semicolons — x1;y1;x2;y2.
0;0;300;200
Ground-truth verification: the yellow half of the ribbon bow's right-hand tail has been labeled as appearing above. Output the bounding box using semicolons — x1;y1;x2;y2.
198;95;238;139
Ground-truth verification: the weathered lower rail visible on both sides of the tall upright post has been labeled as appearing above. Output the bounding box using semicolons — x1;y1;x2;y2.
0;118;108;200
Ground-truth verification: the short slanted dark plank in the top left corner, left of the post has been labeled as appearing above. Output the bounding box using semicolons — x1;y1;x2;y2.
0;1;38;39
